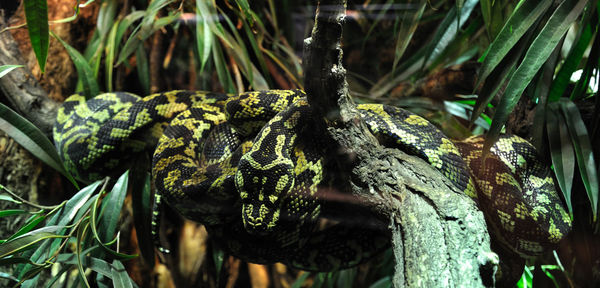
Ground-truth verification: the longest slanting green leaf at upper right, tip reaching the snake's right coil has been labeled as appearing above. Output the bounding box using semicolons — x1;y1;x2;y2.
483;0;587;154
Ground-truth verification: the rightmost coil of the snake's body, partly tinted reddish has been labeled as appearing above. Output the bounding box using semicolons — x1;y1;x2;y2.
456;135;571;257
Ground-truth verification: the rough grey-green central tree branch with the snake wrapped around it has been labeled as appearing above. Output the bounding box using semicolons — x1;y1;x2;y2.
304;0;498;287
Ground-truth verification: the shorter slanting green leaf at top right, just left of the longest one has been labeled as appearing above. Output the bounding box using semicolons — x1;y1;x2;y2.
474;0;553;87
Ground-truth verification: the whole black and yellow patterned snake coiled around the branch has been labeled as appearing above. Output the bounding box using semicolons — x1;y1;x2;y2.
54;90;571;271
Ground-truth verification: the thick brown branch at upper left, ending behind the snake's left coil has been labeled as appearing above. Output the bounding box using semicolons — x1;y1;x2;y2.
0;16;60;135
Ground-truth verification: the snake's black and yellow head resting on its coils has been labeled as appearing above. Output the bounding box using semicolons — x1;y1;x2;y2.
235;151;295;235
